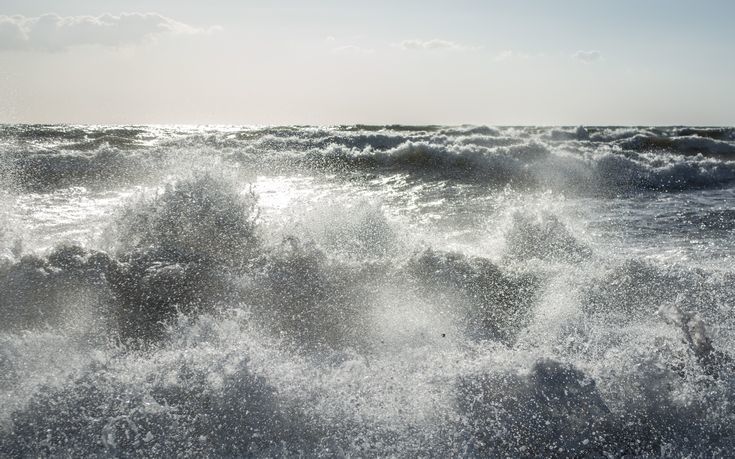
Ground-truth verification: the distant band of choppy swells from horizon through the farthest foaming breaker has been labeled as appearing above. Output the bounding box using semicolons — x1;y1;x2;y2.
5;126;735;195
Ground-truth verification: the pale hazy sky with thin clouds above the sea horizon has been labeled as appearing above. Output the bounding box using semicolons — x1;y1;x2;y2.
0;0;735;125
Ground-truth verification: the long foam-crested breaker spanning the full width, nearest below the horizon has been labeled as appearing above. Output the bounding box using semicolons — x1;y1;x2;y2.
14;138;735;194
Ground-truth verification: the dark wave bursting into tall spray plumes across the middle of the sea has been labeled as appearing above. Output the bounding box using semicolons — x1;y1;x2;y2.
0;173;735;348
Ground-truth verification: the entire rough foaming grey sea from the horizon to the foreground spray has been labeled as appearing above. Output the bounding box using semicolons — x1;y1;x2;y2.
0;125;735;457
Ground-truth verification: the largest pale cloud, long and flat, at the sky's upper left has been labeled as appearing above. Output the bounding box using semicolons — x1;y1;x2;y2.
0;13;219;51
